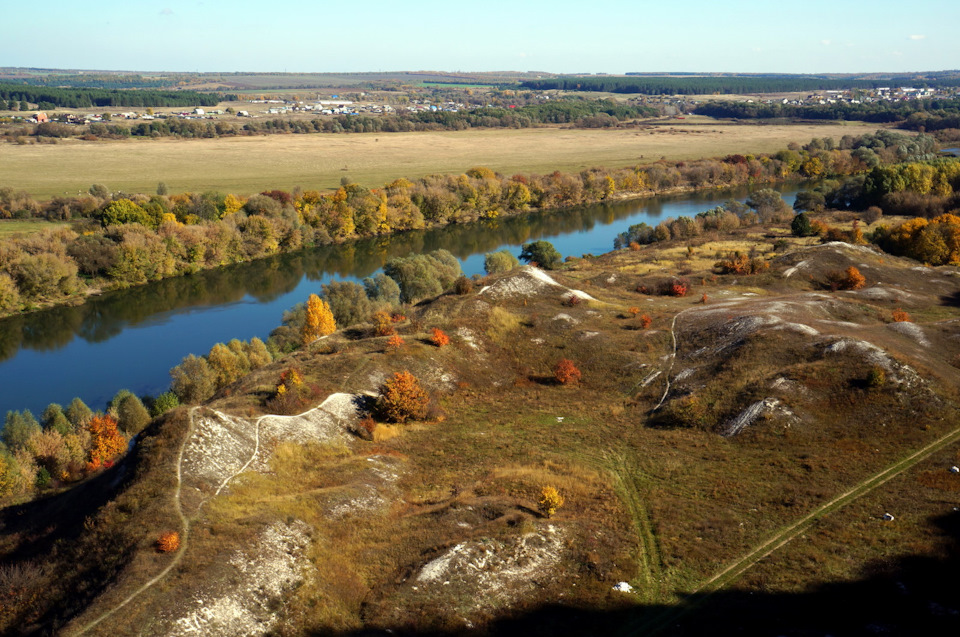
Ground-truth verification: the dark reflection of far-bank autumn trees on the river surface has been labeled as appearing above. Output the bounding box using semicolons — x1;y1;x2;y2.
0;188;788;360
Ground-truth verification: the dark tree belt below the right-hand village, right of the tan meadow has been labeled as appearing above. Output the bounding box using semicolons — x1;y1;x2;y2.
695;98;960;131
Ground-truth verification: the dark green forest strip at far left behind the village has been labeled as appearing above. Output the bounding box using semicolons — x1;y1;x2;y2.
0;82;235;109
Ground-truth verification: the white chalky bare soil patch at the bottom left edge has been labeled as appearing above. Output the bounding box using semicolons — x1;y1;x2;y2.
166;520;310;637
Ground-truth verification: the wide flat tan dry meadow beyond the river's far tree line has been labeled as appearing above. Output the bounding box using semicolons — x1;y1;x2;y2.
0;121;876;197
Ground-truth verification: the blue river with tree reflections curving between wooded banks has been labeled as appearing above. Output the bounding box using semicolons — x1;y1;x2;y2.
0;187;796;418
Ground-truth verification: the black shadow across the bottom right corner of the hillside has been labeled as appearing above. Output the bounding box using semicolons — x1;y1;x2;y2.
314;512;960;637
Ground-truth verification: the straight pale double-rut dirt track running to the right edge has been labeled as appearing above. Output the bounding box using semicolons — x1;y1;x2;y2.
618;420;960;635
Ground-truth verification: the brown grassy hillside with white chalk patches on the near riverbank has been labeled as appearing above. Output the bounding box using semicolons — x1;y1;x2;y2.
0;228;960;635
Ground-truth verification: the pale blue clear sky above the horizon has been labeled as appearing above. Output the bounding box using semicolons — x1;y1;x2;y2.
7;0;960;73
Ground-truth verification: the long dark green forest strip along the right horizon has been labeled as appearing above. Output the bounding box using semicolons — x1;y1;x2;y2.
521;76;960;95
